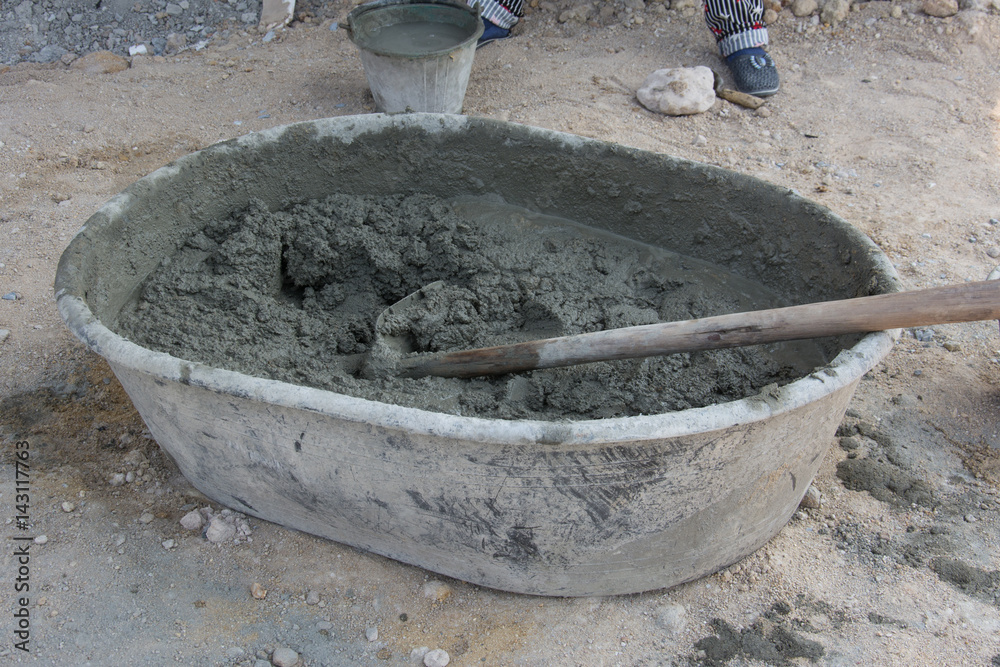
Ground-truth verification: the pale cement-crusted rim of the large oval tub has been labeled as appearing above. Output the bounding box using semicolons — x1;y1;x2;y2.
55;113;900;445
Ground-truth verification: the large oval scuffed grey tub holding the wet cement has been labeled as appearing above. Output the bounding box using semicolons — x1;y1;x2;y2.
56;114;898;596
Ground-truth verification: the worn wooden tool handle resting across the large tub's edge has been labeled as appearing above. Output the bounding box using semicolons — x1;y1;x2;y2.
399;280;1000;378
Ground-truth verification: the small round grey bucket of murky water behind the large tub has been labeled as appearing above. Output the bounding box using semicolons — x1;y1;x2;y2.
346;0;483;114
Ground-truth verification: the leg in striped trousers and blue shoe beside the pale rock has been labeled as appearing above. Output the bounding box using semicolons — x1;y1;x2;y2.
703;0;778;97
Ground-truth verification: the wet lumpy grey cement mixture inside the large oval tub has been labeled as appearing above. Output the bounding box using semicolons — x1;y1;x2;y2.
117;195;822;420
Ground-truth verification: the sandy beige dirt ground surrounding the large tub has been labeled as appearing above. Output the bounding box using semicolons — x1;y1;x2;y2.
0;2;1000;667
